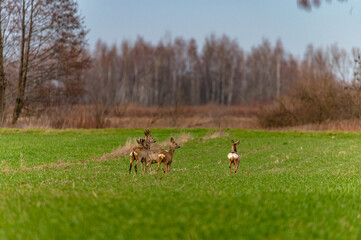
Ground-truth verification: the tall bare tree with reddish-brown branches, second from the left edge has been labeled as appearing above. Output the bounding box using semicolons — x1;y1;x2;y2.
12;0;89;123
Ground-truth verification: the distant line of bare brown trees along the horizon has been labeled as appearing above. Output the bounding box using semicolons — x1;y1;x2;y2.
83;35;357;106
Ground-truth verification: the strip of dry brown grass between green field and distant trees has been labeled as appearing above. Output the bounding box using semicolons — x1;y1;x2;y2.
5;105;259;129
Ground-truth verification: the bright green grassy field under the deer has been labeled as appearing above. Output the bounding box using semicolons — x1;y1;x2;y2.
0;129;361;239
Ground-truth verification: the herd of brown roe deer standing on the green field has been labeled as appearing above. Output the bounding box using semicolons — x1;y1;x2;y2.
129;129;241;174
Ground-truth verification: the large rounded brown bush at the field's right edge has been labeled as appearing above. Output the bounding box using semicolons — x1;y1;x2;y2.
258;74;361;127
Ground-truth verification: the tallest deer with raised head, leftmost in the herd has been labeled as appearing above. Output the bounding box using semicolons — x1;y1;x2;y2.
129;129;156;174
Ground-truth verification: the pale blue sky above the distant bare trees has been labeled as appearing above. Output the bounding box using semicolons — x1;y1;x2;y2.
78;0;361;57
